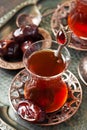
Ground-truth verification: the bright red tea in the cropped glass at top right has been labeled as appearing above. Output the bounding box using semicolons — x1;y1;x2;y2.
68;0;87;39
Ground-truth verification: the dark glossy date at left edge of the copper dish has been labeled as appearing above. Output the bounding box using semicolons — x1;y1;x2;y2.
0;40;23;59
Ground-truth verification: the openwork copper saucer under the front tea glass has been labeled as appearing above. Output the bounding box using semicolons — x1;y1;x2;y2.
9;69;82;126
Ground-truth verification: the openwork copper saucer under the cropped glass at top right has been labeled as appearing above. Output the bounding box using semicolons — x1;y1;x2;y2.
51;0;87;51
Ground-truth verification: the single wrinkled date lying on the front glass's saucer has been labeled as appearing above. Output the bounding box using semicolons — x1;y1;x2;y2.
17;100;45;122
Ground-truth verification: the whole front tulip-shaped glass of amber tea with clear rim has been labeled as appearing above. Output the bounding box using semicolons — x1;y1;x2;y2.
23;40;70;113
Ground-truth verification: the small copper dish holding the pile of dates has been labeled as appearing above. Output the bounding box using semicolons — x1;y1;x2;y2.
0;27;51;70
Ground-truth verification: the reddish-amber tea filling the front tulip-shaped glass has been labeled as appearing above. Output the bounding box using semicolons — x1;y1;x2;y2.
24;49;68;113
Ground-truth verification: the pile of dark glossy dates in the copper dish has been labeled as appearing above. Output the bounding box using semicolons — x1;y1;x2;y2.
0;24;43;61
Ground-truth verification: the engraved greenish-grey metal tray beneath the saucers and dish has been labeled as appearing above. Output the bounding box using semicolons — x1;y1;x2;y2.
0;0;87;130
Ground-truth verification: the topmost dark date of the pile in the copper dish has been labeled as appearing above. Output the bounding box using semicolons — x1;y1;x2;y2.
13;25;38;44
